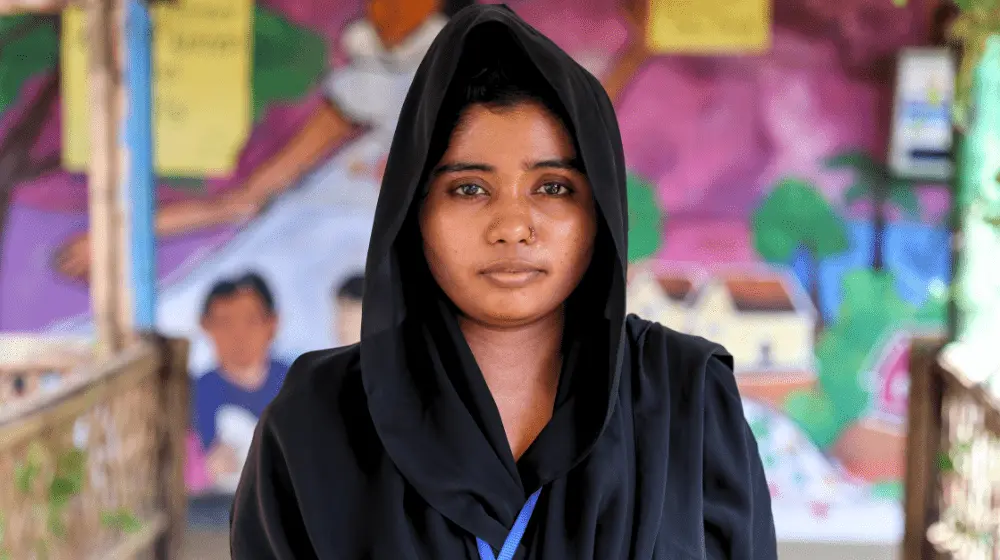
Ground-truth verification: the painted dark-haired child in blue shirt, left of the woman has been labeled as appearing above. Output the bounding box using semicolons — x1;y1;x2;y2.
193;273;288;489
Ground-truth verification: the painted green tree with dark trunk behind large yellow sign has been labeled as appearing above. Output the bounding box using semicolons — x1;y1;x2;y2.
0;6;327;270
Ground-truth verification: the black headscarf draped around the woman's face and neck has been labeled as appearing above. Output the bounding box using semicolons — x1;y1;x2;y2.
361;1;627;542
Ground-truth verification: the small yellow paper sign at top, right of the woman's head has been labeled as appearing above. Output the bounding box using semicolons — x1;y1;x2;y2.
646;0;771;54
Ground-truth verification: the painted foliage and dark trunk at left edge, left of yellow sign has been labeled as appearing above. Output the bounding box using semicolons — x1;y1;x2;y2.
0;14;59;274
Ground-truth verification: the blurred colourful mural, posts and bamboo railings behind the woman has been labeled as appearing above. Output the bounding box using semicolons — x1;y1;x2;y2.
0;0;1000;560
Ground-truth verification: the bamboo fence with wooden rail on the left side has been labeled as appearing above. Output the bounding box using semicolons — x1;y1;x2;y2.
0;337;188;560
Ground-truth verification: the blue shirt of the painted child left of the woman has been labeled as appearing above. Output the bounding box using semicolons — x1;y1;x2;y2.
193;360;288;450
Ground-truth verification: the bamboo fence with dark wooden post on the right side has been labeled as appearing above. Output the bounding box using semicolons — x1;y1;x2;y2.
902;339;1000;560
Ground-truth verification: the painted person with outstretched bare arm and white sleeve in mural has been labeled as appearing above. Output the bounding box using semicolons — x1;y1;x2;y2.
56;0;474;278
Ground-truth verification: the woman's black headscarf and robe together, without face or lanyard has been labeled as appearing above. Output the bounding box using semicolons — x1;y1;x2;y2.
231;6;775;560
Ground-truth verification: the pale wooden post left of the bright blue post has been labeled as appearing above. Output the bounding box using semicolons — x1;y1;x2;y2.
85;0;130;359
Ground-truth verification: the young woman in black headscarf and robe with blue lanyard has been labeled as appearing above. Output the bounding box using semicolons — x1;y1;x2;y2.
231;6;776;560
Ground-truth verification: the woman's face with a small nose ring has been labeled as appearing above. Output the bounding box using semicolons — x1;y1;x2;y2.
420;103;597;327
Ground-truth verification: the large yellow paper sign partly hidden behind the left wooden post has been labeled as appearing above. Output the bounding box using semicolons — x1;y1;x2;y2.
61;0;253;177
